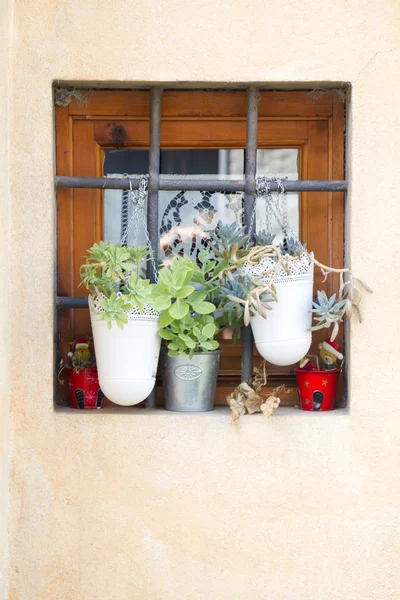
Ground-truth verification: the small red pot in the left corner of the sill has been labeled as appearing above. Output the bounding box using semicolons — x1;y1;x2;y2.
68;367;104;408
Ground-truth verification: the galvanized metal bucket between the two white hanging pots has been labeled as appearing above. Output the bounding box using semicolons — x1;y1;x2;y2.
161;348;222;412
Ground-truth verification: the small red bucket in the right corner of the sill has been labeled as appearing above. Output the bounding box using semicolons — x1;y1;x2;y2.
296;369;340;412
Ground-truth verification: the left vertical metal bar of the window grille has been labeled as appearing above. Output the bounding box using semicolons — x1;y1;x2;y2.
146;87;163;408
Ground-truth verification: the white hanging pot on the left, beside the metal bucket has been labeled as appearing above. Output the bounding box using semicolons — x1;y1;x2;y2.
89;295;161;406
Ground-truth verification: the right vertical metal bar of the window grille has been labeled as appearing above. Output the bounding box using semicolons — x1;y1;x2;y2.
241;87;259;381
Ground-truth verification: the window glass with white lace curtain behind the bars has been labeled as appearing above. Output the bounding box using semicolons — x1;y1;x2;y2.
104;148;299;259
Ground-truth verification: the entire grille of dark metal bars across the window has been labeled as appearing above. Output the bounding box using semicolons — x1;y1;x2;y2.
55;86;347;408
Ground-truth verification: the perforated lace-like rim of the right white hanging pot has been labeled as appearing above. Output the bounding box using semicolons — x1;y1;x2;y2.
238;252;314;283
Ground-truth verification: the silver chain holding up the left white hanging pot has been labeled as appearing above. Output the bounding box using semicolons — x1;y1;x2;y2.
120;175;158;283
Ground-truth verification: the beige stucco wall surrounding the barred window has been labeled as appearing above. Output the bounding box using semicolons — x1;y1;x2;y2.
0;0;400;600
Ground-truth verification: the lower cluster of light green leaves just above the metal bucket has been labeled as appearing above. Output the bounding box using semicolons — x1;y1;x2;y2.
158;314;219;358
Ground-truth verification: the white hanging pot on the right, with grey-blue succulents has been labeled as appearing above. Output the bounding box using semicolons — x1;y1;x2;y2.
243;252;314;366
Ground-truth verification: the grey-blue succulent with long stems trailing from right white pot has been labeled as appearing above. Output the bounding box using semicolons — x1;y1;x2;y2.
206;222;372;340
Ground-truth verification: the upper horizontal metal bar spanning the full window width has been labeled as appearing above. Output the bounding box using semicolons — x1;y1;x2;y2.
55;176;347;193
